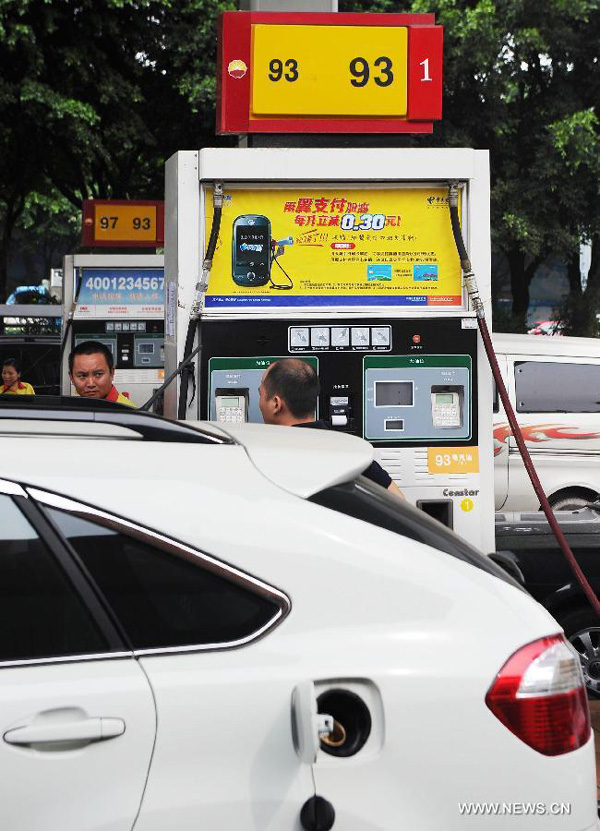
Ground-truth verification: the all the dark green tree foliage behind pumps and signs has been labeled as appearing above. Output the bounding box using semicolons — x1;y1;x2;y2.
0;0;600;333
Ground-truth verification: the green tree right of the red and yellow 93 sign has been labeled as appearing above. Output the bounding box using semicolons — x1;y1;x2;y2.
344;0;600;330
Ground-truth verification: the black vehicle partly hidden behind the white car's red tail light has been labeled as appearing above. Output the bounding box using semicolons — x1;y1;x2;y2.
492;506;600;698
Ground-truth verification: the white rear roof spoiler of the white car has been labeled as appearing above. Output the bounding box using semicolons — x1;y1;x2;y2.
186;422;373;499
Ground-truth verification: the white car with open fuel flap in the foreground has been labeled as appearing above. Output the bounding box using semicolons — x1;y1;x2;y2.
0;397;599;831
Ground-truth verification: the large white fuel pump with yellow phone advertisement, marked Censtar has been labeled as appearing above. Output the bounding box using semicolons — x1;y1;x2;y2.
165;148;494;550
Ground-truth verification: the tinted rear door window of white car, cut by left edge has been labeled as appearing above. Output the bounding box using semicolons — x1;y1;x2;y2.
0;495;108;662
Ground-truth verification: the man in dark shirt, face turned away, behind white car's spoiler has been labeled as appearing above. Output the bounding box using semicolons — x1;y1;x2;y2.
258;358;404;499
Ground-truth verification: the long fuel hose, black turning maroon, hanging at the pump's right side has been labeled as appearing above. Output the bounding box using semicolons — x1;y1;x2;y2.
449;182;600;617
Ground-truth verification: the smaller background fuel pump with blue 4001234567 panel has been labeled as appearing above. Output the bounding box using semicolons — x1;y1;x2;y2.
61;254;165;406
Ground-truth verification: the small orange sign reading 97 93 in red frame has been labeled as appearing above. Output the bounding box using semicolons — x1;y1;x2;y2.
81;199;165;248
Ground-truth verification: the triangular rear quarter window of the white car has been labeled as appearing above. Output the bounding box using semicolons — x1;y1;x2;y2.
46;508;281;650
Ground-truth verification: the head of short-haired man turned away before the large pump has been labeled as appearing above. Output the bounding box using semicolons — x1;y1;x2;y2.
258;358;319;425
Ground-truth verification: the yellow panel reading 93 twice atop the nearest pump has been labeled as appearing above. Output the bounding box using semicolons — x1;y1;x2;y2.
251;25;408;117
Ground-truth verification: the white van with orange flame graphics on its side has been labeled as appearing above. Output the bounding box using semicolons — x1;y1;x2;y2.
493;334;600;511
